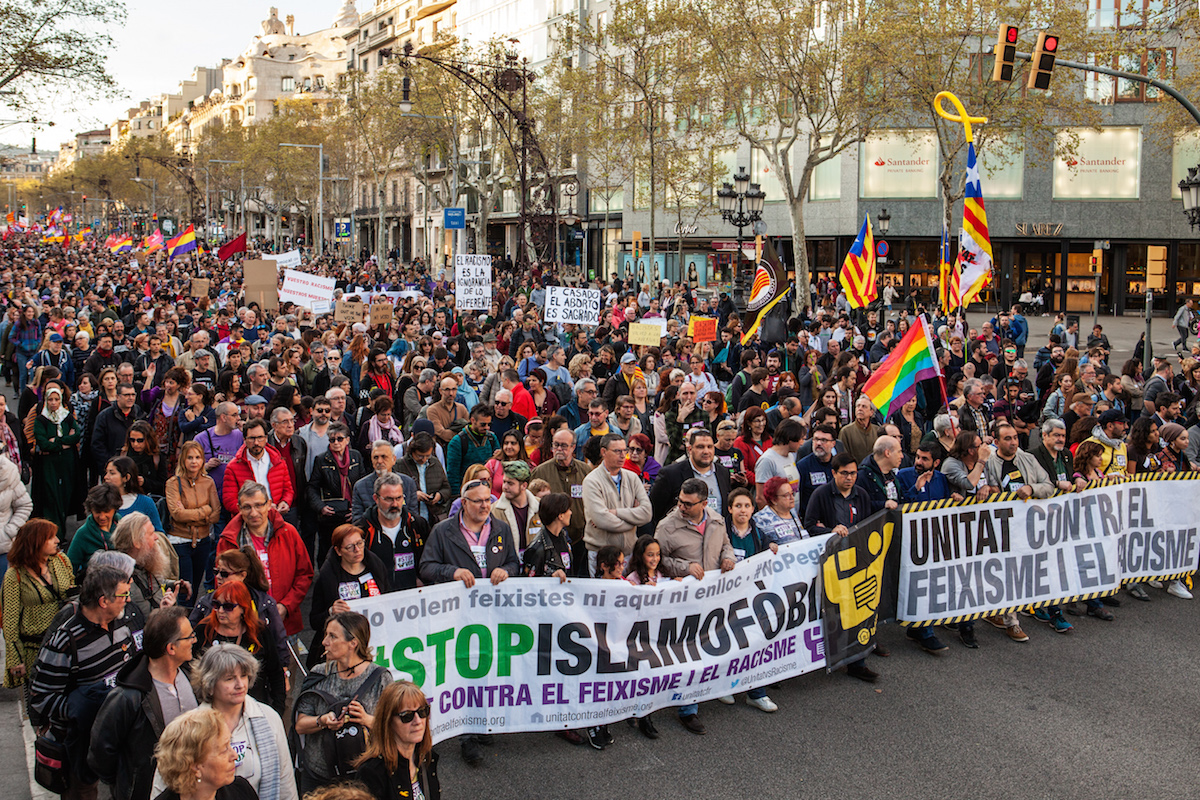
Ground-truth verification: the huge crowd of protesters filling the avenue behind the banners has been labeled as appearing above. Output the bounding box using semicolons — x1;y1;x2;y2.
0;240;1200;800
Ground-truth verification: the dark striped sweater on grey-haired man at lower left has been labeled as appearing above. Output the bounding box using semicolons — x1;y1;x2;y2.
30;610;138;726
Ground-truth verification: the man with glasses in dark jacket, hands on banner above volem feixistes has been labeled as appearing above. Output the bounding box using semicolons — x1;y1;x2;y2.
420;481;521;766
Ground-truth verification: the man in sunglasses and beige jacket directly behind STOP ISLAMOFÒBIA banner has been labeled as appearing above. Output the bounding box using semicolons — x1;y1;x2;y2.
654;477;737;735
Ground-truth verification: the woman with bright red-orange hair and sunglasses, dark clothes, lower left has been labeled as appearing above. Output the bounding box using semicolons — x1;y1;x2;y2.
194;581;287;714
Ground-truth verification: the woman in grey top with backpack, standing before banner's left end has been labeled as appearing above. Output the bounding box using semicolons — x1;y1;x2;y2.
292;612;391;796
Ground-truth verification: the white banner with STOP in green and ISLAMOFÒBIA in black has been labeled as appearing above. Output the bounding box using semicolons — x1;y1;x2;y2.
350;536;828;741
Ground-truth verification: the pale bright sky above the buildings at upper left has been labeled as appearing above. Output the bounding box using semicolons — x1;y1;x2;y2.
8;0;348;152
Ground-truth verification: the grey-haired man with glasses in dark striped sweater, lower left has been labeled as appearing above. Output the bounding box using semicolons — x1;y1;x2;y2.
29;566;138;800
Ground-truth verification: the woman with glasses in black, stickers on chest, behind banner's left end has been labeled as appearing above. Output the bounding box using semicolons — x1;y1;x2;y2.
307;525;391;669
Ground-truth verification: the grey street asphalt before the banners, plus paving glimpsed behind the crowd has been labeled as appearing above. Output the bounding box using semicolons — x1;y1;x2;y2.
0;313;1200;800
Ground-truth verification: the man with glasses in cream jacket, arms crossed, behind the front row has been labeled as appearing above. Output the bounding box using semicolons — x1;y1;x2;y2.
583;433;653;577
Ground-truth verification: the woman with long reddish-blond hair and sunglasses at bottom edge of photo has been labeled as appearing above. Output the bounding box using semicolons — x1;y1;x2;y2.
359;680;442;800
